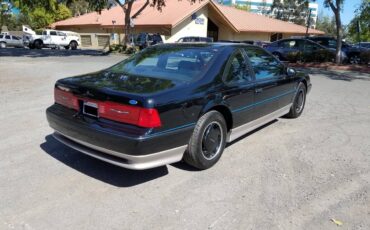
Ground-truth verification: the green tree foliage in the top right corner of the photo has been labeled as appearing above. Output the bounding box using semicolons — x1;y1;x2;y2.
348;0;370;42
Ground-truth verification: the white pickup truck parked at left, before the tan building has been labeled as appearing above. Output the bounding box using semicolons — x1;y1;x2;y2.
23;26;80;50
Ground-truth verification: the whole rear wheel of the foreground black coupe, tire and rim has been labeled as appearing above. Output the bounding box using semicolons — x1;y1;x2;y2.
183;111;227;170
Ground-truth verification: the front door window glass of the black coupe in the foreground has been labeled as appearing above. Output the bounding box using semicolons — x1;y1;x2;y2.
244;46;284;81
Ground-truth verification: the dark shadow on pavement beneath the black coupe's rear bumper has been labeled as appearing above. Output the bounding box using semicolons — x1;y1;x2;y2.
40;135;168;187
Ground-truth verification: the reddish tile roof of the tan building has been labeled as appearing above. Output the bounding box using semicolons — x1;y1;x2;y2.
52;0;324;34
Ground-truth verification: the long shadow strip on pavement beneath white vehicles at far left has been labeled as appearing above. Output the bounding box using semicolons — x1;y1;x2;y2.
0;48;106;58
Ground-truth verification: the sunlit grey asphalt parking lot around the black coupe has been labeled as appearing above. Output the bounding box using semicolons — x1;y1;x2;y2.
0;50;370;230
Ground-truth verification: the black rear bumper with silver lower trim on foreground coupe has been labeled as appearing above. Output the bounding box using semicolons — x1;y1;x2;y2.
46;105;192;169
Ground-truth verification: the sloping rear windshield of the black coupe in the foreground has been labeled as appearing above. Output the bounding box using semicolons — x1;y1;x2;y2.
109;46;219;81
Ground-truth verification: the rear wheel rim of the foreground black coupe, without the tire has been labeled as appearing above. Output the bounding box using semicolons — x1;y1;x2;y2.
201;121;224;160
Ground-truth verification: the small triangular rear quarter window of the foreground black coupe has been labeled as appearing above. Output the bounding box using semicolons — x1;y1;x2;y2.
225;50;252;84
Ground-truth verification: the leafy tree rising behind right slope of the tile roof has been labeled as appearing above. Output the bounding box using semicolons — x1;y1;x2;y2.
270;0;309;25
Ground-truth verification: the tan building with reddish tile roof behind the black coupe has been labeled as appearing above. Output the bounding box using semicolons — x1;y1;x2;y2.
52;0;323;48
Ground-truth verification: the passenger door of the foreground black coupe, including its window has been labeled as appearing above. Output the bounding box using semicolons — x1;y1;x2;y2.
244;46;295;119
